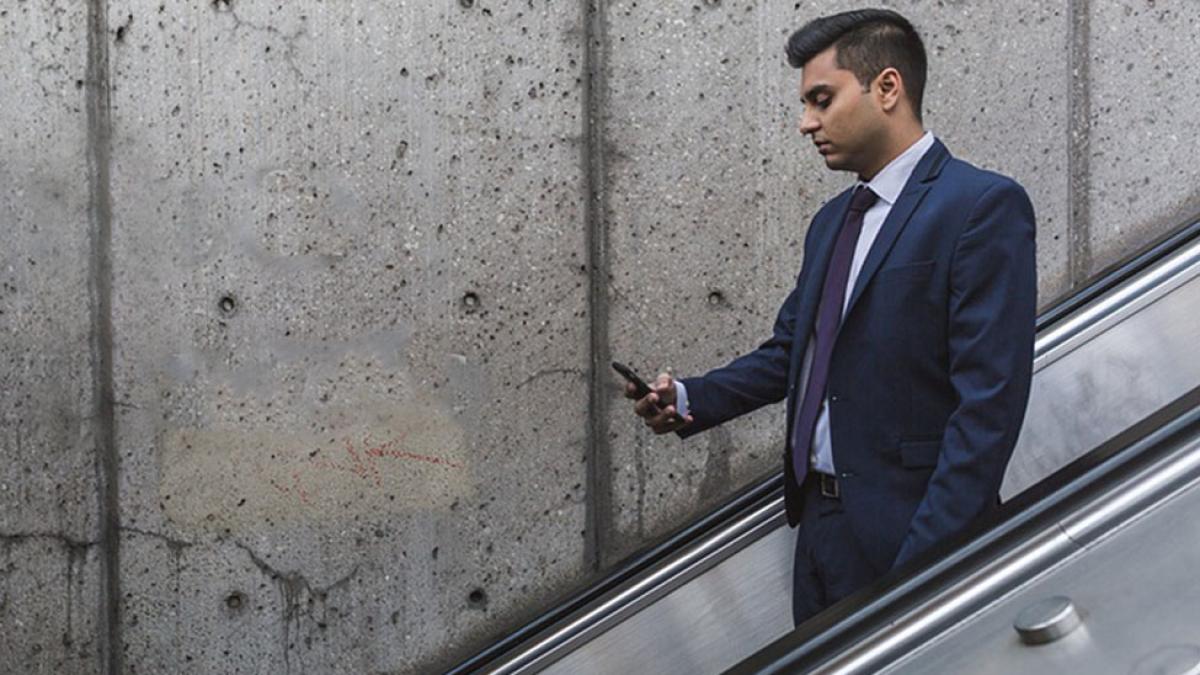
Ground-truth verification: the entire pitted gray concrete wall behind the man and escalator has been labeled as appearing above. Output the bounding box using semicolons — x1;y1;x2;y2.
0;0;1200;673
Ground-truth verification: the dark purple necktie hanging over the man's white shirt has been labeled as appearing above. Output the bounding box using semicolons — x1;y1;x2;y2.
792;186;878;485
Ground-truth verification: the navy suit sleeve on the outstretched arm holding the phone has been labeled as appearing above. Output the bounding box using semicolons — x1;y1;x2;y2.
677;278;799;438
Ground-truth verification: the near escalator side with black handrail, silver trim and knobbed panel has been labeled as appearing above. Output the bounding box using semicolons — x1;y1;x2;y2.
731;387;1200;675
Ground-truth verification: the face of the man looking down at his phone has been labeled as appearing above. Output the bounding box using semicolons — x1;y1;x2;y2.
800;47;886;174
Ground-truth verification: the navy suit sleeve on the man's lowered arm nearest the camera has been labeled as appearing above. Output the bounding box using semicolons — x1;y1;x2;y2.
894;179;1037;567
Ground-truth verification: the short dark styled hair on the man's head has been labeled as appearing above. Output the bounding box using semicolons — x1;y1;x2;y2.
787;10;926;120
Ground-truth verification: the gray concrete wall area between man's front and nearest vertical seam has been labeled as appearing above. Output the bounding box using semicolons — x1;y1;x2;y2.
605;2;811;558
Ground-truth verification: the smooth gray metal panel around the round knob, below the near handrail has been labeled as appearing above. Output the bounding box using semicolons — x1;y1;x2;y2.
886;444;1200;675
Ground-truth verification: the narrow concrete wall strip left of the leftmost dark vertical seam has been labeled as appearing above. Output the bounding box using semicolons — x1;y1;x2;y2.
0;2;103;674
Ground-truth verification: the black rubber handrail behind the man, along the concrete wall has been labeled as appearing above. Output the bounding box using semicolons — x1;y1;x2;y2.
448;213;1200;675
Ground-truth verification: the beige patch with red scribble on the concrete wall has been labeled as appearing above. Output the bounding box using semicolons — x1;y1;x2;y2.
158;398;474;534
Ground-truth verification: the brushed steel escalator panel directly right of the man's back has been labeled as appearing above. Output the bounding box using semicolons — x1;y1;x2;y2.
1001;237;1200;498
